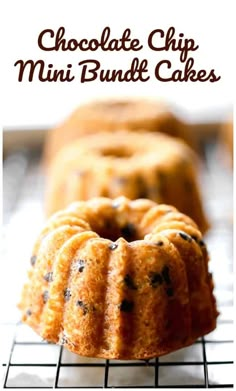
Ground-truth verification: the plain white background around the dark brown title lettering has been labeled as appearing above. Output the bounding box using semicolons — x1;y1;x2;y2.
1;0;235;128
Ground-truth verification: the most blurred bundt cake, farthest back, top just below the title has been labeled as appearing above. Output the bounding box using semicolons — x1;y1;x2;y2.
44;99;196;165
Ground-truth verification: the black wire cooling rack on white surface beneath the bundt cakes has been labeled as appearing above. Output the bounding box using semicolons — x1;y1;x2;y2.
0;140;234;388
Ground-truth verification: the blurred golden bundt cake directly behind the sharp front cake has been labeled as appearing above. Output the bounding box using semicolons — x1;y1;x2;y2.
45;131;208;232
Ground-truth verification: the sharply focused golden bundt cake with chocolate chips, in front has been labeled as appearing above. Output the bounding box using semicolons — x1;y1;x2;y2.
19;197;218;359
